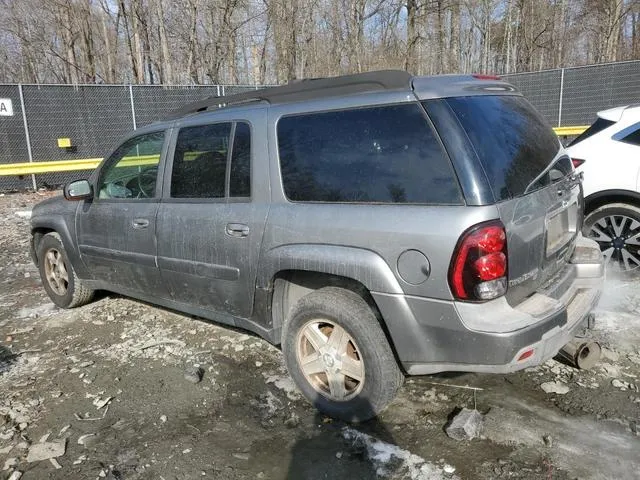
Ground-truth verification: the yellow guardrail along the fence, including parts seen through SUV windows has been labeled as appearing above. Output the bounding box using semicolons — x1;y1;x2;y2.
0;126;589;176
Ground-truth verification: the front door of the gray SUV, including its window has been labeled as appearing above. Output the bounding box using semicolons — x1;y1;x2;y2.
76;131;167;297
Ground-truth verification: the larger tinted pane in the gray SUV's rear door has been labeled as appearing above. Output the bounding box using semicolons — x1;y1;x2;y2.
171;123;231;198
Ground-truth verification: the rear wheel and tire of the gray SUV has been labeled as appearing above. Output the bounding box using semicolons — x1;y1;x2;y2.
282;287;404;422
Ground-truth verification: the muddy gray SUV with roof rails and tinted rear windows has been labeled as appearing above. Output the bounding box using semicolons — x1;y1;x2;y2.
31;71;604;421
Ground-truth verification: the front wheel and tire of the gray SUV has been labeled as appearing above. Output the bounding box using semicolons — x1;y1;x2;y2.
38;233;94;308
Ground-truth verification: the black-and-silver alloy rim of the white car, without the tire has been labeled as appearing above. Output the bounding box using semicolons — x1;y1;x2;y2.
588;215;640;272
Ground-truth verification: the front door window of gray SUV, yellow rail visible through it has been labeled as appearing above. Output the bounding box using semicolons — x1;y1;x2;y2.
98;132;164;198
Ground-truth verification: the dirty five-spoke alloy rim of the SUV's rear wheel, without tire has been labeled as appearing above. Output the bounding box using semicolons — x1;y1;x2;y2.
296;320;365;402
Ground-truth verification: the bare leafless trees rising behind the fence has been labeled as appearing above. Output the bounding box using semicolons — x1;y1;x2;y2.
0;0;640;84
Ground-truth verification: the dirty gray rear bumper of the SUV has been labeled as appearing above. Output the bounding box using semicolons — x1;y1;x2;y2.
373;238;604;375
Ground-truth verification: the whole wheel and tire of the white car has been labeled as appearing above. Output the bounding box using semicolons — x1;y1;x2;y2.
582;203;640;275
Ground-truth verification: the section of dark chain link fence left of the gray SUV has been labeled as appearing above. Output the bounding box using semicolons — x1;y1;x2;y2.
0;85;256;191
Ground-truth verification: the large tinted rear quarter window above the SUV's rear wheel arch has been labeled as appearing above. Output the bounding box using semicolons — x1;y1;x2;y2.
278;103;462;204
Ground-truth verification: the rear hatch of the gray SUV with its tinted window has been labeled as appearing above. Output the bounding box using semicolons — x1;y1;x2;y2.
425;94;582;305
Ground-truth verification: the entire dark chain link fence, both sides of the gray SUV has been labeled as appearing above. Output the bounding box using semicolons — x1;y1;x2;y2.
0;61;640;191
